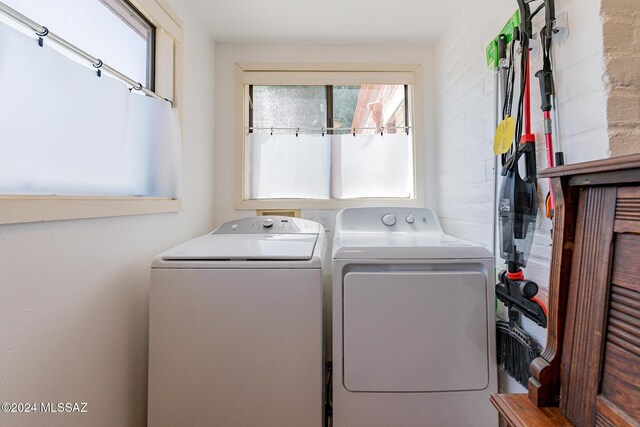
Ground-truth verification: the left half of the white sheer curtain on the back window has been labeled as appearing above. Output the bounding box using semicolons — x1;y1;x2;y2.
248;133;331;199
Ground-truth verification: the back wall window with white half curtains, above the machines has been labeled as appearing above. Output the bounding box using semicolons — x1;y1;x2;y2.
238;65;422;209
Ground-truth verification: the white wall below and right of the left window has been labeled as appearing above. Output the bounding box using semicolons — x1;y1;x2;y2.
0;1;214;426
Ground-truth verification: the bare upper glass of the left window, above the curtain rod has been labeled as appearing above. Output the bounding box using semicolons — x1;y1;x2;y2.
0;0;154;90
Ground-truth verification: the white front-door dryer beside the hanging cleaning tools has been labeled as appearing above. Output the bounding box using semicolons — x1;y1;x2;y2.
333;208;498;427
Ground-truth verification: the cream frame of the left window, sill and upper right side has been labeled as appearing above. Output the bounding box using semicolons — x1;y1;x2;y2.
0;0;183;225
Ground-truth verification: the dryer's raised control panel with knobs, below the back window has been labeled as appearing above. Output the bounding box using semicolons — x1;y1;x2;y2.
336;208;442;233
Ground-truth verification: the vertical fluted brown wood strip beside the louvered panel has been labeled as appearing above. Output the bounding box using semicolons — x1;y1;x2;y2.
560;187;617;426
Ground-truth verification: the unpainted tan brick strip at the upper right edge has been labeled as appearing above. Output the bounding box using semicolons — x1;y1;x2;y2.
602;0;640;156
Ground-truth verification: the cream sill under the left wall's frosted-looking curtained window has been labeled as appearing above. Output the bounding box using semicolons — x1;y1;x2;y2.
0;196;182;224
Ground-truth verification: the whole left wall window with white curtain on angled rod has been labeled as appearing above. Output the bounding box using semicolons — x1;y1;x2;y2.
0;0;182;224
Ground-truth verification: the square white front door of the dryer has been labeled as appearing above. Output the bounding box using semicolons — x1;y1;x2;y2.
343;271;489;392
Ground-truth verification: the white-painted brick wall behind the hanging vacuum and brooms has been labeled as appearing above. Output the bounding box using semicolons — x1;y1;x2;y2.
436;0;609;391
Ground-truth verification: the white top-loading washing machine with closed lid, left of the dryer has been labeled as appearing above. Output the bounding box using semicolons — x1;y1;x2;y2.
148;217;325;427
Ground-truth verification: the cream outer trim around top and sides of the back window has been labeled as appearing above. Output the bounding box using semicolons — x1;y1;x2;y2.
214;43;437;224
